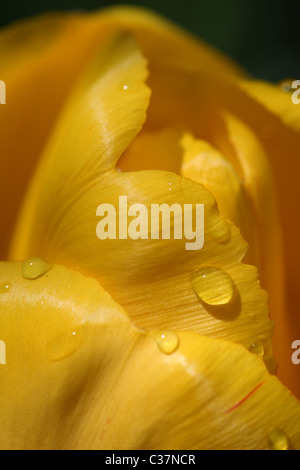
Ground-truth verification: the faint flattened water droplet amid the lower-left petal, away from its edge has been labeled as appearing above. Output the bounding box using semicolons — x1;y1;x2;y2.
47;329;83;361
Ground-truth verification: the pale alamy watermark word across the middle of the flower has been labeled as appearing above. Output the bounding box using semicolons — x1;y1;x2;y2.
96;196;204;250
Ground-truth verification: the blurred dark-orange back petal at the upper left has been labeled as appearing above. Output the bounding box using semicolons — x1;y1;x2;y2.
0;13;113;257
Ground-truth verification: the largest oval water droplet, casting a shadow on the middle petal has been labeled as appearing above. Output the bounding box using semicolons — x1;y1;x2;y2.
191;266;237;306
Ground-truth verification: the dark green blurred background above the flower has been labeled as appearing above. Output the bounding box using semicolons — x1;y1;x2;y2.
0;0;300;82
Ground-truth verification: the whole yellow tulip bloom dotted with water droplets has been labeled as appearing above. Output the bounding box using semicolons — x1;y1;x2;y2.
0;6;300;450
